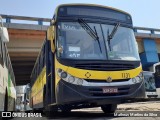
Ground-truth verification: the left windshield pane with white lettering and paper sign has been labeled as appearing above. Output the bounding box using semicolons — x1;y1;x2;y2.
57;22;106;59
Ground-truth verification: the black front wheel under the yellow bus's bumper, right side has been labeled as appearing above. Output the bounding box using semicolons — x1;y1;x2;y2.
101;104;117;114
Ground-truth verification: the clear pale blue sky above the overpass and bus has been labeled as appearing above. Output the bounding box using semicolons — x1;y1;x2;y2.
0;0;160;29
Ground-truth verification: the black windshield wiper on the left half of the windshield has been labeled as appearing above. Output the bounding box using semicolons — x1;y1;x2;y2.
78;18;102;53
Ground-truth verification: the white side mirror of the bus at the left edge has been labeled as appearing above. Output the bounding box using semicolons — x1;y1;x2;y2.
0;27;9;43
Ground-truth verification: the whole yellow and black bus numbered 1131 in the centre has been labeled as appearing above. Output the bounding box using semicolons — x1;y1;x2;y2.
31;4;145;113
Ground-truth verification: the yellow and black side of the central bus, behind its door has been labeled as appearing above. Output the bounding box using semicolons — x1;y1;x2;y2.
30;41;47;109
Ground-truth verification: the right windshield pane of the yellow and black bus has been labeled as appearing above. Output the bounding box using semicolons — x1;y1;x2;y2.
102;25;140;60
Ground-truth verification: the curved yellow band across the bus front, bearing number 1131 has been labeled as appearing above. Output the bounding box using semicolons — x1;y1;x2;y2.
55;58;142;85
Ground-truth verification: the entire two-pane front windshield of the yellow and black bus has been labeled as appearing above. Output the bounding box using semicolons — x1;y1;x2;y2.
57;22;140;61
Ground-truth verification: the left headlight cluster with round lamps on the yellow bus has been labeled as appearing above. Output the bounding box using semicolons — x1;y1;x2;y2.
57;69;84;85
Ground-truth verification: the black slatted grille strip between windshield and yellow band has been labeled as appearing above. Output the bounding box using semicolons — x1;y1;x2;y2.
75;63;135;71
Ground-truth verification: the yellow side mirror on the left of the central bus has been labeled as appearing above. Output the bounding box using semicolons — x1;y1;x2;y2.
47;26;55;53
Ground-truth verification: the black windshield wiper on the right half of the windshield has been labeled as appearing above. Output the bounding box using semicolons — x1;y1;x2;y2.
107;23;120;51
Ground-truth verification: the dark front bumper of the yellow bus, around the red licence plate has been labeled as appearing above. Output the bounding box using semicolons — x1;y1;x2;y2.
56;80;145;105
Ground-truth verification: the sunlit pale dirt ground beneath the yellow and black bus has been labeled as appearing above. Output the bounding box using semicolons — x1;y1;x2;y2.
13;101;160;120
